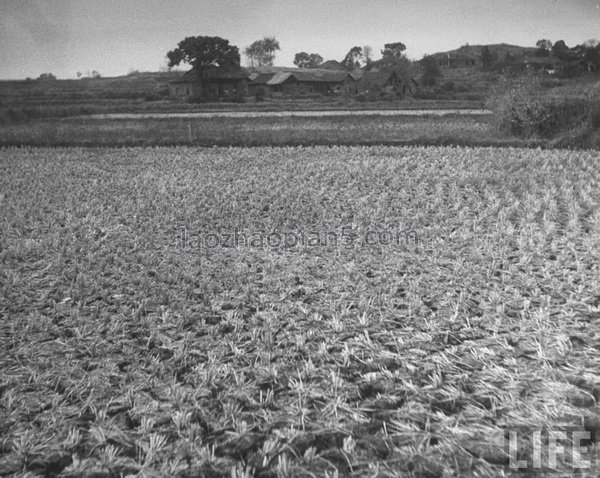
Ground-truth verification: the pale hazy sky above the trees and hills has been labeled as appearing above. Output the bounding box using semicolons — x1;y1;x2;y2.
0;0;600;79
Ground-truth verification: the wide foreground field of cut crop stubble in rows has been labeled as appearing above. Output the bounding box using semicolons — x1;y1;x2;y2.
0;147;600;477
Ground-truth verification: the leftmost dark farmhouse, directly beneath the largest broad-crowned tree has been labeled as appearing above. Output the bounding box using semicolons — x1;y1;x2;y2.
169;67;249;99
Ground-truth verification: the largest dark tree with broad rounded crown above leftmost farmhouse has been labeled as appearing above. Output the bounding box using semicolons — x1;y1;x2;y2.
167;36;240;74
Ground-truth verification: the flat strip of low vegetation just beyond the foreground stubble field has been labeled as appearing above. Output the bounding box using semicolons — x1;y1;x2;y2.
0;116;500;146
